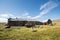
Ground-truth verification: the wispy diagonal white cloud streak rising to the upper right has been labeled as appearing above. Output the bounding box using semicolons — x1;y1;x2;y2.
34;1;58;19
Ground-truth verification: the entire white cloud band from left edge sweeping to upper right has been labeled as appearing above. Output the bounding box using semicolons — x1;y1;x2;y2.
0;0;58;22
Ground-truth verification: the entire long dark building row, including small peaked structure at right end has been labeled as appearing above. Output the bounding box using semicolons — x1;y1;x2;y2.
7;18;52;28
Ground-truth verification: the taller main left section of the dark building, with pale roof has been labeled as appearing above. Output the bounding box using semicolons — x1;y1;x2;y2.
7;18;38;28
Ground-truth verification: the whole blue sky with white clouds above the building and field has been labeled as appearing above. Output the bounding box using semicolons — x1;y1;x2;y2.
0;0;60;22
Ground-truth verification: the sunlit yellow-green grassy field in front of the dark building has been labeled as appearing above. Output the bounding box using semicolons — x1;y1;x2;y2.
0;20;60;40
